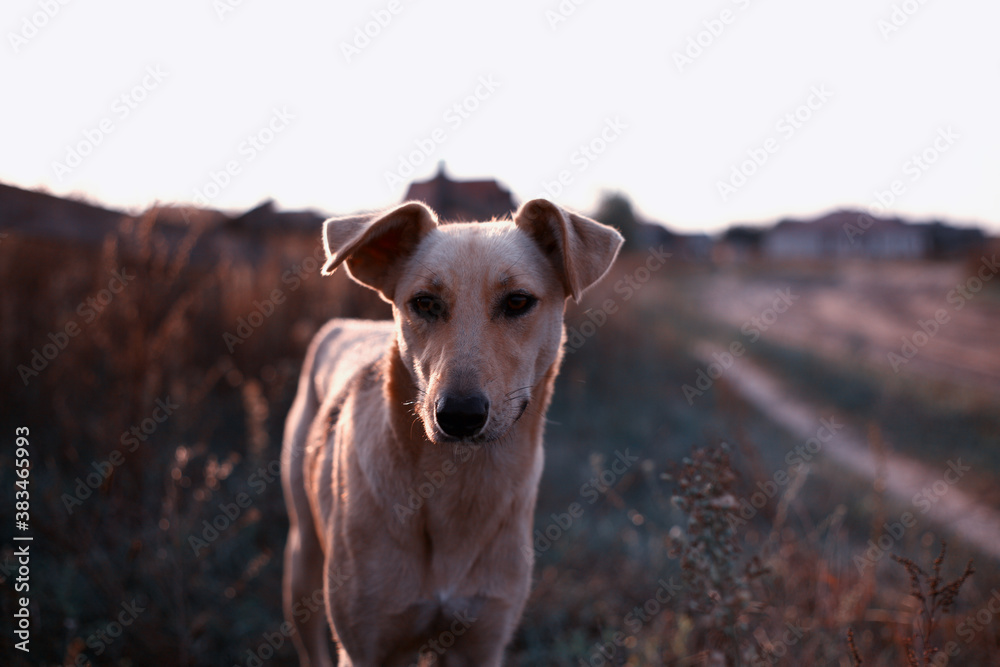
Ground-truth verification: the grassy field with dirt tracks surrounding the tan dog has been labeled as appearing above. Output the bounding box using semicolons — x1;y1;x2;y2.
0;216;1000;667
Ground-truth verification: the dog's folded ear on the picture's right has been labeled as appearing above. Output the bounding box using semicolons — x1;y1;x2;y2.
514;199;625;303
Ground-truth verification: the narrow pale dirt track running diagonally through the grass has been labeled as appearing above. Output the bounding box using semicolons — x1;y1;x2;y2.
695;343;1000;559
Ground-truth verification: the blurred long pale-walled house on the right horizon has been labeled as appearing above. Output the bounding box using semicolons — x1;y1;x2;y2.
762;211;930;259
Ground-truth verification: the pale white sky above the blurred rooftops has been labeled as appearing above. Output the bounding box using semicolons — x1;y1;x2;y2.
0;0;1000;233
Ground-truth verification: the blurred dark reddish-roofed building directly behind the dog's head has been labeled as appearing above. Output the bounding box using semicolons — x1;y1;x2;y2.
404;162;515;221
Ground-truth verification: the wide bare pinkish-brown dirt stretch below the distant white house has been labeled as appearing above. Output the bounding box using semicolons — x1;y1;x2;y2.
700;262;1000;392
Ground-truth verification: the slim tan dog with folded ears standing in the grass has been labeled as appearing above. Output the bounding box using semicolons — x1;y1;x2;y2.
282;199;622;667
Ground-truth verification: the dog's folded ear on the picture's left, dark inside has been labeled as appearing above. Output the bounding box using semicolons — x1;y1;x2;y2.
322;202;437;302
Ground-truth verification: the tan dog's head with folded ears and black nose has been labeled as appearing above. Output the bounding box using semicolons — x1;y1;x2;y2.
323;199;622;443
